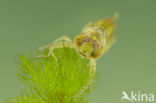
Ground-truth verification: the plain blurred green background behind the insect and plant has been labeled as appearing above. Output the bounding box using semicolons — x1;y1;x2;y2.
0;0;156;103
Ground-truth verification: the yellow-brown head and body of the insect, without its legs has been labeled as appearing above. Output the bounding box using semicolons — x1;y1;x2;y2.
74;18;115;59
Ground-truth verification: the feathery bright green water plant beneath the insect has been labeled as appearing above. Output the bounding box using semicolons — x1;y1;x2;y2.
8;48;93;103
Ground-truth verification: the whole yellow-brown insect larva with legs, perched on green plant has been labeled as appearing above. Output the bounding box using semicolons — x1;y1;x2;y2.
37;13;118;99
